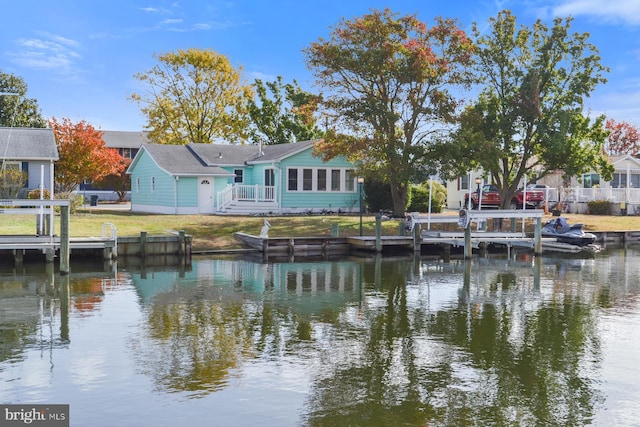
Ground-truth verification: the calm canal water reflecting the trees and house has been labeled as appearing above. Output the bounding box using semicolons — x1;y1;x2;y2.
0;249;640;427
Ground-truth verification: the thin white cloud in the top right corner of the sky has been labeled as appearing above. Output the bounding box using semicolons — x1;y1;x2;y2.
553;0;640;25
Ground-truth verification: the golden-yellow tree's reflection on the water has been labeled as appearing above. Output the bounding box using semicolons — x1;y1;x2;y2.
145;287;255;396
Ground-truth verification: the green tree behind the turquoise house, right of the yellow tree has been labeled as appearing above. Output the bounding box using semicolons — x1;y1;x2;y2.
247;76;323;145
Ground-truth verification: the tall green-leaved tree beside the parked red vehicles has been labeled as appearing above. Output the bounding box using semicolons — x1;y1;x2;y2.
435;11;612;208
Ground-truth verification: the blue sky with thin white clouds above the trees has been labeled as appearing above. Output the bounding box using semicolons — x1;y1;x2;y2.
0;0;640;131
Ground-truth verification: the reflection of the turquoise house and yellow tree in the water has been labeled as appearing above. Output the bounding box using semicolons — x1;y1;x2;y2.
128;260;361;397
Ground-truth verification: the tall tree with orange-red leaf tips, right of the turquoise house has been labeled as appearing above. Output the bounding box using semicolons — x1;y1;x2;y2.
304;9;473;215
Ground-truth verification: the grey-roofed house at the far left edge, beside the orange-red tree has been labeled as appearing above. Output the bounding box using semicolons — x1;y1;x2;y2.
0;127;58;198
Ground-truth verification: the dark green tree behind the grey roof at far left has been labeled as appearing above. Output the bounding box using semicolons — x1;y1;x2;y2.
0;72;47;128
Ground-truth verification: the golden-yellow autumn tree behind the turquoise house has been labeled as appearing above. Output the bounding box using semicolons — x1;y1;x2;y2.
131;48;252;144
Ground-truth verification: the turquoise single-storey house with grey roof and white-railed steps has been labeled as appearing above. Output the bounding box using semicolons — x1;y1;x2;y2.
127;141;359;214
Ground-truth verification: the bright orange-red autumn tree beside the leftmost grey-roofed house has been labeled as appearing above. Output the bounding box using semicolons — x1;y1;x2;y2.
49;117;122;193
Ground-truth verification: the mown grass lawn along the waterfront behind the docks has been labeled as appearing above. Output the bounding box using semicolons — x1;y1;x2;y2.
0;209;640;251
